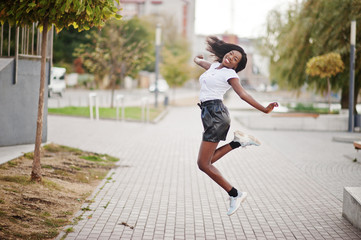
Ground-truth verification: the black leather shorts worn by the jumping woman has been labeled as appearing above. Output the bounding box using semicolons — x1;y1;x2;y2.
199;100;231;142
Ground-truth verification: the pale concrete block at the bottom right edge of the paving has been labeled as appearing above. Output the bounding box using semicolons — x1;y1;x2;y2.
342;187;361;230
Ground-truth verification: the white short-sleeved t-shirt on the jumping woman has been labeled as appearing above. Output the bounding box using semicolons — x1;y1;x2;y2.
199;62;239;102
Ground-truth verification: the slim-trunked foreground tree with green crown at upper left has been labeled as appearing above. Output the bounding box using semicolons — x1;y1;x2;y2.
0;0;121;182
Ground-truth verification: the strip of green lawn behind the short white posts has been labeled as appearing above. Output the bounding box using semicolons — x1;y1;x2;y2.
48;107;163;121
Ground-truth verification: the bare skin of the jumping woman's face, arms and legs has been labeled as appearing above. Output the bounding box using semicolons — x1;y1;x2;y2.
194;50;278;192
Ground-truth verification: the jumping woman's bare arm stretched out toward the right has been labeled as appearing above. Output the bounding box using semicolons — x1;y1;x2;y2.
228;78;278;113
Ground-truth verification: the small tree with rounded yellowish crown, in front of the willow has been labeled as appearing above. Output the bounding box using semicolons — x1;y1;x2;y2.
306;53;345;111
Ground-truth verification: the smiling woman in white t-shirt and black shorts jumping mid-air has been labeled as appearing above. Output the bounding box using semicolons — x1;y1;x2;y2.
194;37;278;216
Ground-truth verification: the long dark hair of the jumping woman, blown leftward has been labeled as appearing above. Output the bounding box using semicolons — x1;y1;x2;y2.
206;36;247;72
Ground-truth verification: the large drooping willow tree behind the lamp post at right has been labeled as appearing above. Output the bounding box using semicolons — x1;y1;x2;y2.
263;0;361;108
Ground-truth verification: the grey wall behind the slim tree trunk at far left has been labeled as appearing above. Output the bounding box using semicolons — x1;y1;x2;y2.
0;59;49;146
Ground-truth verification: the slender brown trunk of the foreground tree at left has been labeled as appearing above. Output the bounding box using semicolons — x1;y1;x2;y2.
31;20;48;182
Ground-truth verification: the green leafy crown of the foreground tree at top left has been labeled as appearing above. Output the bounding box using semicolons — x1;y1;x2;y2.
0;0;121;31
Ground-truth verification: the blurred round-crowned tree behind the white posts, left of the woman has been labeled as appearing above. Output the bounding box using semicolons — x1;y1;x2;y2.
75;18;152;107
